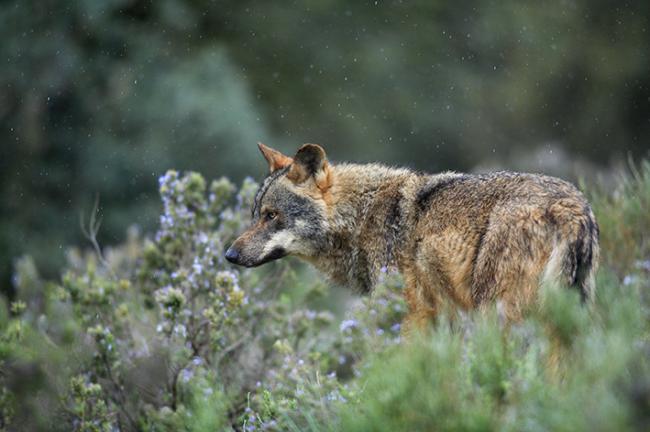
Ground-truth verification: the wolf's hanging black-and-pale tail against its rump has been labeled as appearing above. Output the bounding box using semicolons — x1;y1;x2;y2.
543;202;600;301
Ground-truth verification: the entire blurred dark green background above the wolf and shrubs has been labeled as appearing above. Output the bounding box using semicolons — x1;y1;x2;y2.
0;0;650;292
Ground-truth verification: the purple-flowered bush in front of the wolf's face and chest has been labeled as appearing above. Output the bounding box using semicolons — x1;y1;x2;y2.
2;171;405;431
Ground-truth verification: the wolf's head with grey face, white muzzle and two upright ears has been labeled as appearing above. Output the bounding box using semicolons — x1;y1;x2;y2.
226;143;332;267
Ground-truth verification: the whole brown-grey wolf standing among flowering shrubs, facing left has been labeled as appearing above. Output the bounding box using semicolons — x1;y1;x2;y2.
225;143;599;328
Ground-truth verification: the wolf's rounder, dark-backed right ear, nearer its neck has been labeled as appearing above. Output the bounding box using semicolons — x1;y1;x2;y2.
287;144;332;191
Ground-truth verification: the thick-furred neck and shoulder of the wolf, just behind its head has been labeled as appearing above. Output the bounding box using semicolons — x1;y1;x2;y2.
315;164;424;291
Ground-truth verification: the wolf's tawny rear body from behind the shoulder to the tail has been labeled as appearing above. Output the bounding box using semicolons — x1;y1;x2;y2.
415;172;599;308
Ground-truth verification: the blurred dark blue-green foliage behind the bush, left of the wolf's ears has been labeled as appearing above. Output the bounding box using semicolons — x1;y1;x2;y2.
0;1;266;290
